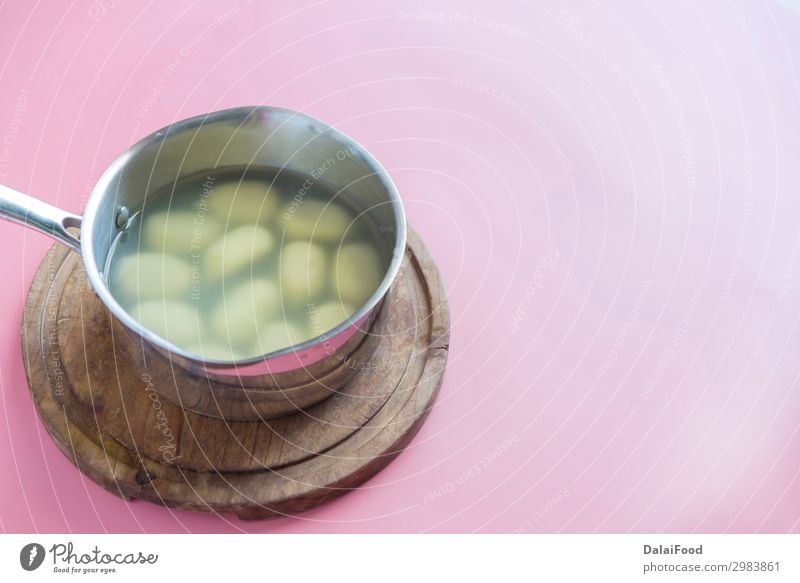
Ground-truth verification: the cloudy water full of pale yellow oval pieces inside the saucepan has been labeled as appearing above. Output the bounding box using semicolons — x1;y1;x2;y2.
107;172;388;364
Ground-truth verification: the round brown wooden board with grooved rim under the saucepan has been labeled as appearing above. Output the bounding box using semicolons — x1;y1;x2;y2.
22;232;450;519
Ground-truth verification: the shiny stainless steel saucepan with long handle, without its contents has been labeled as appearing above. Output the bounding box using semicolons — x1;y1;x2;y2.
0;107;406;418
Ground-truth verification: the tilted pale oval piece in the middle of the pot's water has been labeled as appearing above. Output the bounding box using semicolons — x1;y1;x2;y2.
201;225;275;279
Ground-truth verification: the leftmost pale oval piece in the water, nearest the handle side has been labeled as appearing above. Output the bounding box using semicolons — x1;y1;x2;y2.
111;252;192;301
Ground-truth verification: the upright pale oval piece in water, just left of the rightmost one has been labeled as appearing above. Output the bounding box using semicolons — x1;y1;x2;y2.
280;241;329;306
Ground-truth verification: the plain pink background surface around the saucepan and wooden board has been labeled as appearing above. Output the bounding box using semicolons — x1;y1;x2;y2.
0;0;800;532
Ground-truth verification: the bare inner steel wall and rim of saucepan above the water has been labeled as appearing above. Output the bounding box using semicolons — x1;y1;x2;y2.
82;107;405;360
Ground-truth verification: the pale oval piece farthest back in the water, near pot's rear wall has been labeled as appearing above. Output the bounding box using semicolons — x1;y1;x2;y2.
206;179;281;224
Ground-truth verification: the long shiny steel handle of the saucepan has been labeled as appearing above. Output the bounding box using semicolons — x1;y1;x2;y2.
0;184;81;253
